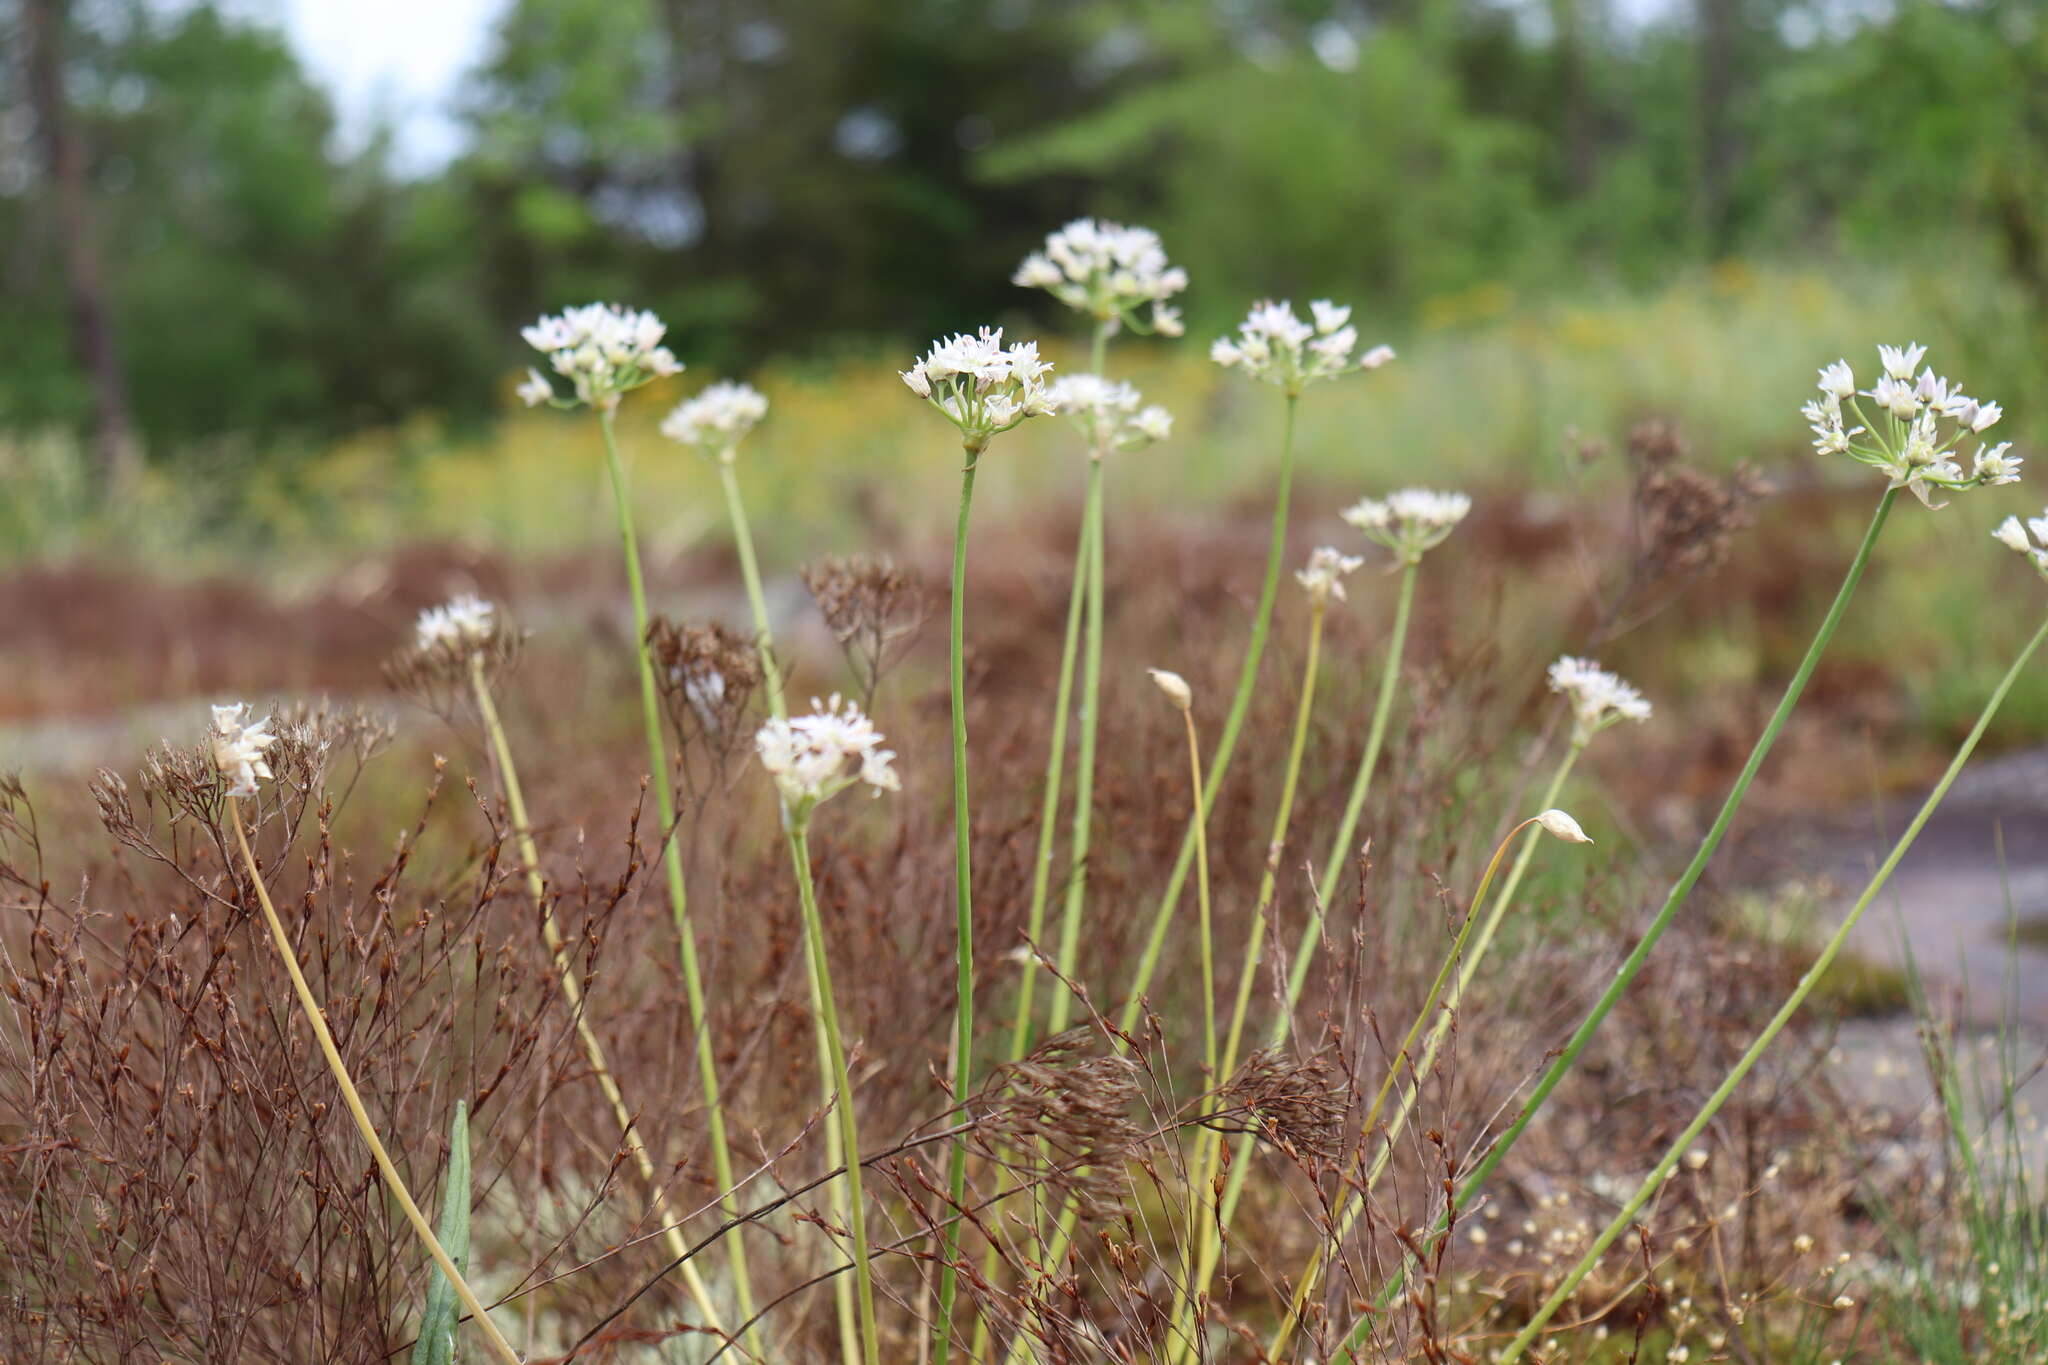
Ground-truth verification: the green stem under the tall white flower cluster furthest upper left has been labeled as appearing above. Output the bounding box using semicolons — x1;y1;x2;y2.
598;409;768;1359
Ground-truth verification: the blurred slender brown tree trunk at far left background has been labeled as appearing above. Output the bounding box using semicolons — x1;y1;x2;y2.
23;0;137;495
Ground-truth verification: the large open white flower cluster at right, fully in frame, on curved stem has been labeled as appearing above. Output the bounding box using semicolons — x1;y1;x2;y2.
1800;342;2019;508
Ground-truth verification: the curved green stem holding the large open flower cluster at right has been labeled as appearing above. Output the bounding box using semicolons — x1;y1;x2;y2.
1331;489;1898;1365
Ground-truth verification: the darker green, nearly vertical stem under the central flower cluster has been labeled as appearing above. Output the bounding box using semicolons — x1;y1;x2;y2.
932;444;981;1365
